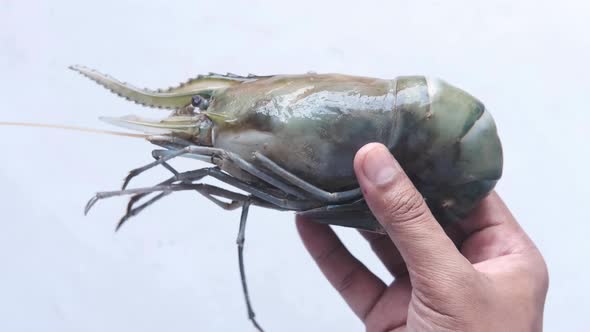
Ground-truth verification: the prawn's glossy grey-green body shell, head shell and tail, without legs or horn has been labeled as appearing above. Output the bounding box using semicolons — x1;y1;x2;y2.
207;74;502;222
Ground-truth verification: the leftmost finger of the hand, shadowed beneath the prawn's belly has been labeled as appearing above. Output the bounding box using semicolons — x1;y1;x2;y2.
297;217;386;321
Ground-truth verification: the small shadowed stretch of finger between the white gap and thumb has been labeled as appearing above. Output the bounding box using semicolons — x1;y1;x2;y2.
359;231;408;279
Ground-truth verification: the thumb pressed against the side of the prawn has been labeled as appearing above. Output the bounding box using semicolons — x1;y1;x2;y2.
354;143;470;278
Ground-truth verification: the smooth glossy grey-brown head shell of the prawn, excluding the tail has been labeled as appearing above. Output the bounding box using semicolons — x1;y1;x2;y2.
208;74;395;191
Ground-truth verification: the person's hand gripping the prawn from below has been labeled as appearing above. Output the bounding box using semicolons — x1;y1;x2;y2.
297;143;549;331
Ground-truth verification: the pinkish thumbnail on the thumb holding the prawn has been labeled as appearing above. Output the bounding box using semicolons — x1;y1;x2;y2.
363;146;397;186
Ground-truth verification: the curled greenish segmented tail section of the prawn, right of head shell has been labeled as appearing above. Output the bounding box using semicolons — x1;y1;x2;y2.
392;77;503;224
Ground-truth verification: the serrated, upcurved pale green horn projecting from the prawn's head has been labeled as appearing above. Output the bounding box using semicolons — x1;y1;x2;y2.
69;65;259;110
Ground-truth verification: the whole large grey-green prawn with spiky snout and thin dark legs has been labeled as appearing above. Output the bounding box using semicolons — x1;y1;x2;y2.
71;66;502;330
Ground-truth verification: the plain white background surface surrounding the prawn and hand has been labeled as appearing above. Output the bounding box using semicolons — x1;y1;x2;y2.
0;0;590;332
